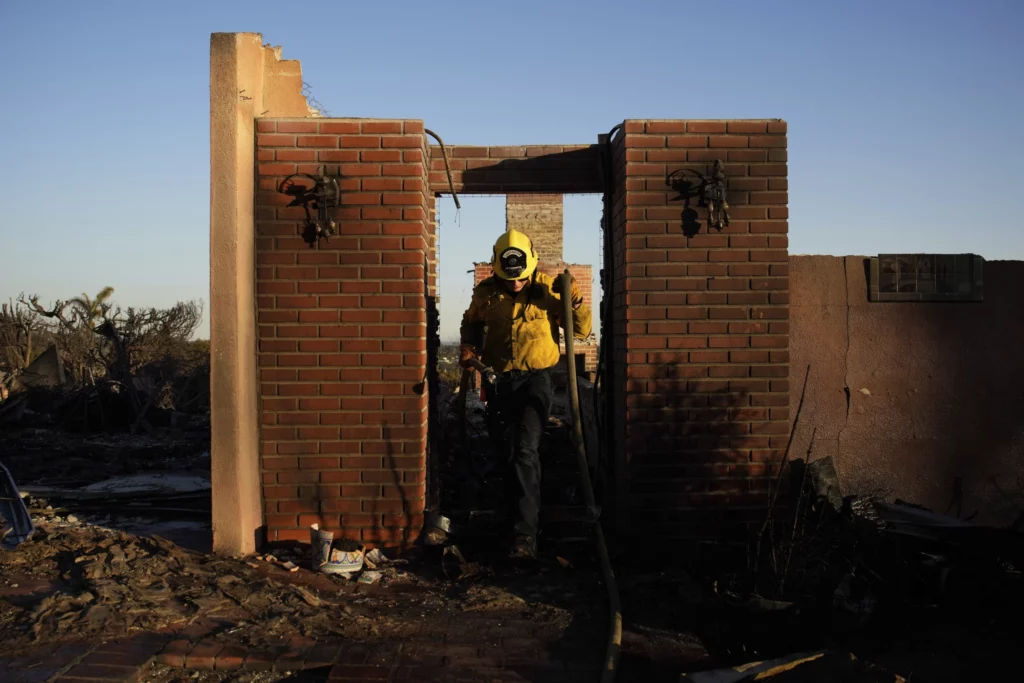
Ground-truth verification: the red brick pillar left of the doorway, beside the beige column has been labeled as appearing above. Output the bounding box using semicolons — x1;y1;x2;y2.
256;119;435;544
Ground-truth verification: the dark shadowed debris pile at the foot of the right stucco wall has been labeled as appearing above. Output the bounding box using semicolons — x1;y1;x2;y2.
749;458;1024;625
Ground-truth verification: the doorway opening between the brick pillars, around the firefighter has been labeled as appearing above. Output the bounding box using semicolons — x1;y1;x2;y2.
428;193;603;539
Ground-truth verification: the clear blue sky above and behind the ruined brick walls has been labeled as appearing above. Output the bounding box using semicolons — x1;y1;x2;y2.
0;0;1024;337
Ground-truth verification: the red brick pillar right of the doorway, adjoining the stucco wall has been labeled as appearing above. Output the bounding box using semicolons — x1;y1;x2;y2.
612;120;790;538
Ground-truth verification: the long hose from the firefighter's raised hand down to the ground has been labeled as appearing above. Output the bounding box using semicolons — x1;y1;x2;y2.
559;269;623;683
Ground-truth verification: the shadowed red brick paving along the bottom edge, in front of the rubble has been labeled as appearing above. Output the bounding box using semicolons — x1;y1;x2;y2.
0;573;604;683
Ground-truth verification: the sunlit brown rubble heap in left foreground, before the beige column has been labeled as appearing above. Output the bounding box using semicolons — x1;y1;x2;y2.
0;525;368;647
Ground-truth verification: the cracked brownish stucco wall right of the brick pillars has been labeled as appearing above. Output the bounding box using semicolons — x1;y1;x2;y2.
790;256;1024;522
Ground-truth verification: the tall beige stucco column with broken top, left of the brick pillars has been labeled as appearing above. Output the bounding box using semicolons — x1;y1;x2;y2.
210;33;310;555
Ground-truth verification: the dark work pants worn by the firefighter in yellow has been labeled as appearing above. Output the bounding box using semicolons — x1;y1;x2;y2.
487;370;554;539
